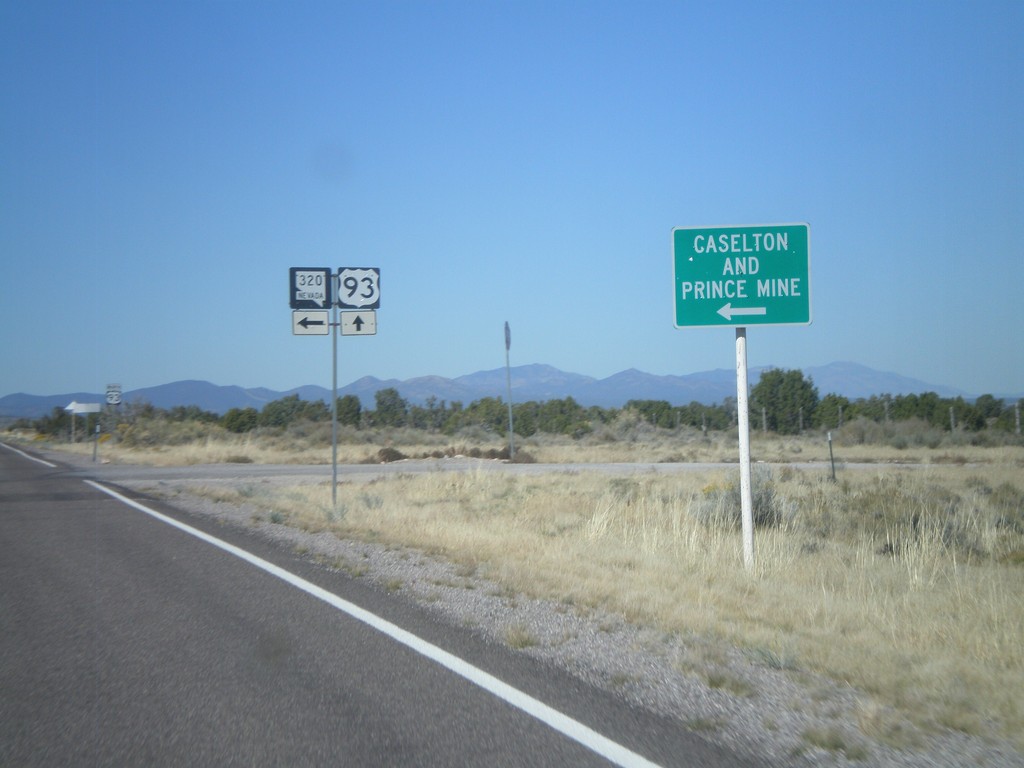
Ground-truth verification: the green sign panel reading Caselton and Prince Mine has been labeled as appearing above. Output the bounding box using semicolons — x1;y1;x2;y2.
672;224;811;328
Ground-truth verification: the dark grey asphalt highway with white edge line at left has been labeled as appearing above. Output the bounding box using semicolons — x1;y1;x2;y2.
0;447;751;766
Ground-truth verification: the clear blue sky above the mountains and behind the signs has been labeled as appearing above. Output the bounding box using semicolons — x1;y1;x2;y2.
0;0;1024;394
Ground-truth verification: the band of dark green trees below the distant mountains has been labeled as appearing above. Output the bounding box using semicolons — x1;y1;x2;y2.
13;369;1020;438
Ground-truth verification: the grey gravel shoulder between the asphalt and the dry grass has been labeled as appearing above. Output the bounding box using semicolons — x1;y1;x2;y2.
39;454;1024;768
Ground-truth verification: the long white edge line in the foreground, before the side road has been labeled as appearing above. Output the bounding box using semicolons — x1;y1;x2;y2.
86;481;657;768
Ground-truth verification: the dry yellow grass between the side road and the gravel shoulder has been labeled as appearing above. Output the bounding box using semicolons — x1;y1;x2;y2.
205;464;1024;746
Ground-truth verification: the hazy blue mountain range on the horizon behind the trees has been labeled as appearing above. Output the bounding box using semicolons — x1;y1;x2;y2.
0;362;1007;420
